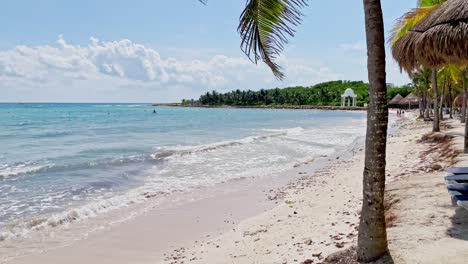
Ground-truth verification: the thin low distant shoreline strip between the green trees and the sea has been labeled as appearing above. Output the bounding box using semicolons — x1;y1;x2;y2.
151;103;367;111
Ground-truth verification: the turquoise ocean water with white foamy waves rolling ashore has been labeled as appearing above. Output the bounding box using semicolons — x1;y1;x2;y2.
0;103;366;243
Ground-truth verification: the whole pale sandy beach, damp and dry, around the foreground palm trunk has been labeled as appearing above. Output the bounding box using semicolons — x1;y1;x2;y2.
8;110;468;264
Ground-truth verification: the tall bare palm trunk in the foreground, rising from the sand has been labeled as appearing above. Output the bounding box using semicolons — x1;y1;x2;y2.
357;0;388;262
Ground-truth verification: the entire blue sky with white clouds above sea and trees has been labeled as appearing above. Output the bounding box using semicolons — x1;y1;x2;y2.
0;0;416;102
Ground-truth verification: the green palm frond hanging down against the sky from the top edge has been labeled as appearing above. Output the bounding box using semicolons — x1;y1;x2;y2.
237;0;308;79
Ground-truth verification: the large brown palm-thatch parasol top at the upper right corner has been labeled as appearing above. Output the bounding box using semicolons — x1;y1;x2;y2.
392;0;468;73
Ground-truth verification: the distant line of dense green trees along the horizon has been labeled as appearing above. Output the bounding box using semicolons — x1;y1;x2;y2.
182;81;412;106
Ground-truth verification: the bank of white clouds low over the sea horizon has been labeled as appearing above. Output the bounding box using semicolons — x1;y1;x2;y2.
0;36;337;102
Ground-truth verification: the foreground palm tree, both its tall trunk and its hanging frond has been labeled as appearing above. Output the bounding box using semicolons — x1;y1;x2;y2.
199;0;388;262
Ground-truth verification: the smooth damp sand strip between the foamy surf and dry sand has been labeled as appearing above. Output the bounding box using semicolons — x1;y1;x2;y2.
0;119;370;264
